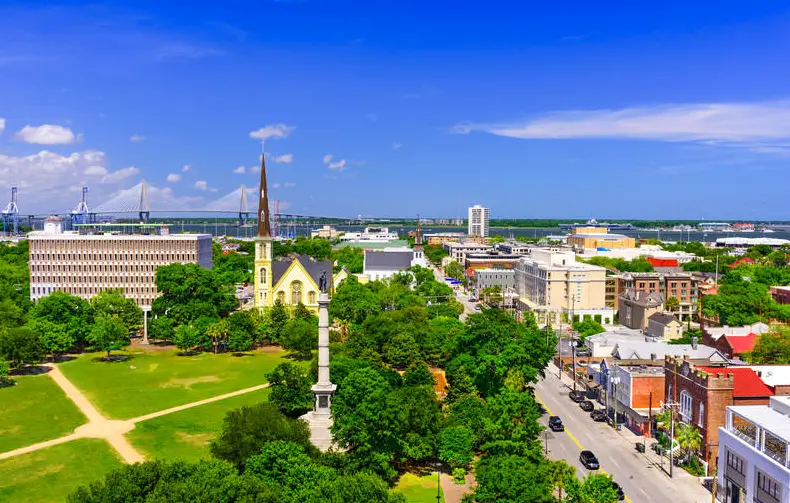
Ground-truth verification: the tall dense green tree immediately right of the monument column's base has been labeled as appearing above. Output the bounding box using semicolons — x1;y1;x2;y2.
331;368;400;477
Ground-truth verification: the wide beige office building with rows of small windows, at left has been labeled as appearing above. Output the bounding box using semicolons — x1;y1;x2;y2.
28;217;211;308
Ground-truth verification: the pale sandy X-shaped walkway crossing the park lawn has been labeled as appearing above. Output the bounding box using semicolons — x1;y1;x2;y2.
0;363;269;464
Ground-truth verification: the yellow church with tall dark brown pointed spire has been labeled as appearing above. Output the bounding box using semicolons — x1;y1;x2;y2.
253;146;333;313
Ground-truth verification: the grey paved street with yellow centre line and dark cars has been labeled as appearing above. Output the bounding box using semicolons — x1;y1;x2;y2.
536;365;711;503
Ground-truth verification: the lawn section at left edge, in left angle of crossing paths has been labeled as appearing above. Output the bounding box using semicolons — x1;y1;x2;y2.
0;375;86;452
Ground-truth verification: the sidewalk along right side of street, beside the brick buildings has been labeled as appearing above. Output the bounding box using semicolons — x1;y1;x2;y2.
546;363;711;501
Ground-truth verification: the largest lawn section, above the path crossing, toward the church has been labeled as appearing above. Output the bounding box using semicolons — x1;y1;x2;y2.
60;349;292;419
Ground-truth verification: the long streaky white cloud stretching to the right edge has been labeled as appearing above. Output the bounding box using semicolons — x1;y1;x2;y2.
451;101;790;146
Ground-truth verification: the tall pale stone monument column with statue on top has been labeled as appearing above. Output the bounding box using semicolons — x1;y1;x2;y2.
300;288;337;451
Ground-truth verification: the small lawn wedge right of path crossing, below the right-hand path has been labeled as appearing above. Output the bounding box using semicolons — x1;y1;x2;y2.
126;389;269;461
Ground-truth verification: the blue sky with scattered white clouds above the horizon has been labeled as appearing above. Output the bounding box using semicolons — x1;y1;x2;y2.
0;0;790;220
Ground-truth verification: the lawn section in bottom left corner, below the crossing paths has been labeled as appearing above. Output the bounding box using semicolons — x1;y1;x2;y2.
0;438;123;503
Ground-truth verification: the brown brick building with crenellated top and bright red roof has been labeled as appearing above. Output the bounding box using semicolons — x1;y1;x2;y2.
664;356;774;465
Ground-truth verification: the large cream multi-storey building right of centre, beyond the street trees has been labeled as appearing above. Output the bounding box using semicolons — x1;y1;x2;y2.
515;248;614;324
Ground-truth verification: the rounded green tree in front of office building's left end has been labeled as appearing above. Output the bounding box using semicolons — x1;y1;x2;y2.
29;292;93;344
